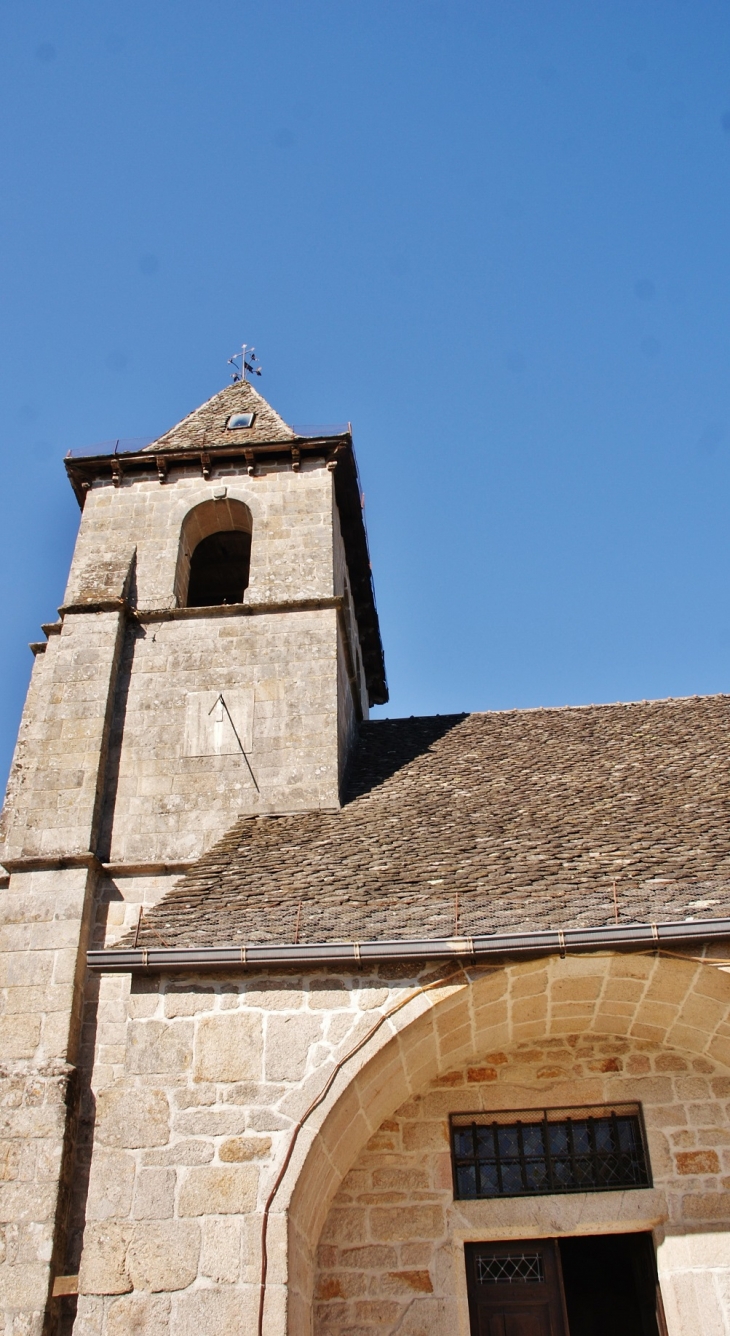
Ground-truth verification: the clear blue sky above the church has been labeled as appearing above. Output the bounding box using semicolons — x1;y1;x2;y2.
0;0;730;771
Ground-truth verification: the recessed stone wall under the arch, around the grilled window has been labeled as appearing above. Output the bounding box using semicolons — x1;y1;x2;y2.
314;1035;730;1336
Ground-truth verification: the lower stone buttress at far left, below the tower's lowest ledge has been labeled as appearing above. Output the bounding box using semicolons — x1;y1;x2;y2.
0;867;102;1336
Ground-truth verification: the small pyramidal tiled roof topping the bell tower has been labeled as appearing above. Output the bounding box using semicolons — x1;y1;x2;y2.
144;381;295;454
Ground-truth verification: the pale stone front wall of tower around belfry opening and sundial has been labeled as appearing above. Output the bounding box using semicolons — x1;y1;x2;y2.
54;461;366;864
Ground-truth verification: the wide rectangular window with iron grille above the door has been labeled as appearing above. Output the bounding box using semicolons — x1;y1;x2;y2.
451;1104;651;1198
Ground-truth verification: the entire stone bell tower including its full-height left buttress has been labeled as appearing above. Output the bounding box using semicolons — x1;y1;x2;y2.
0;382;388;1336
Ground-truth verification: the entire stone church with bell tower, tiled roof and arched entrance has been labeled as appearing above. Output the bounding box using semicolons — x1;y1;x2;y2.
0;381;730;1336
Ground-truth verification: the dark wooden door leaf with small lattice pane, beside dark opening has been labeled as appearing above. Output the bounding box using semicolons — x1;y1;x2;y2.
464;1238;568;1336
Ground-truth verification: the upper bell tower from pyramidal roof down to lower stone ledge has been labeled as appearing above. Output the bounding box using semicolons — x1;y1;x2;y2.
5;381;388;864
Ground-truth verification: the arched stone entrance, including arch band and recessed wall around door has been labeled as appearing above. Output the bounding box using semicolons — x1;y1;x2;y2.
271;954;730;1336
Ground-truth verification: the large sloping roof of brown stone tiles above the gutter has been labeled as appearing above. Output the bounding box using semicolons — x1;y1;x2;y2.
127;696;730;947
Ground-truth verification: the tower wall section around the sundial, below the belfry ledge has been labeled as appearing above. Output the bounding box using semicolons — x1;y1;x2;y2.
95;608;340;863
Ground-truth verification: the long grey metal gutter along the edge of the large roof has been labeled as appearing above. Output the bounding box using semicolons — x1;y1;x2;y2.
87;918;730;974
